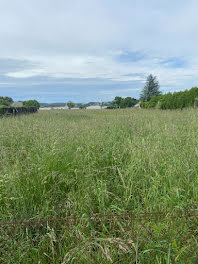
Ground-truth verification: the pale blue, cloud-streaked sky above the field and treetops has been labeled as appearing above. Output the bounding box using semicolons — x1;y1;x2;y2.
0;0;198;103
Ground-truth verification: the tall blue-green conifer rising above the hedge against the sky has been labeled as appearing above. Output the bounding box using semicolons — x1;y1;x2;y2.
140;74;161;102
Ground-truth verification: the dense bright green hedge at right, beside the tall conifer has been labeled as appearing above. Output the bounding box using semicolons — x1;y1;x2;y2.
141;87;198;109
